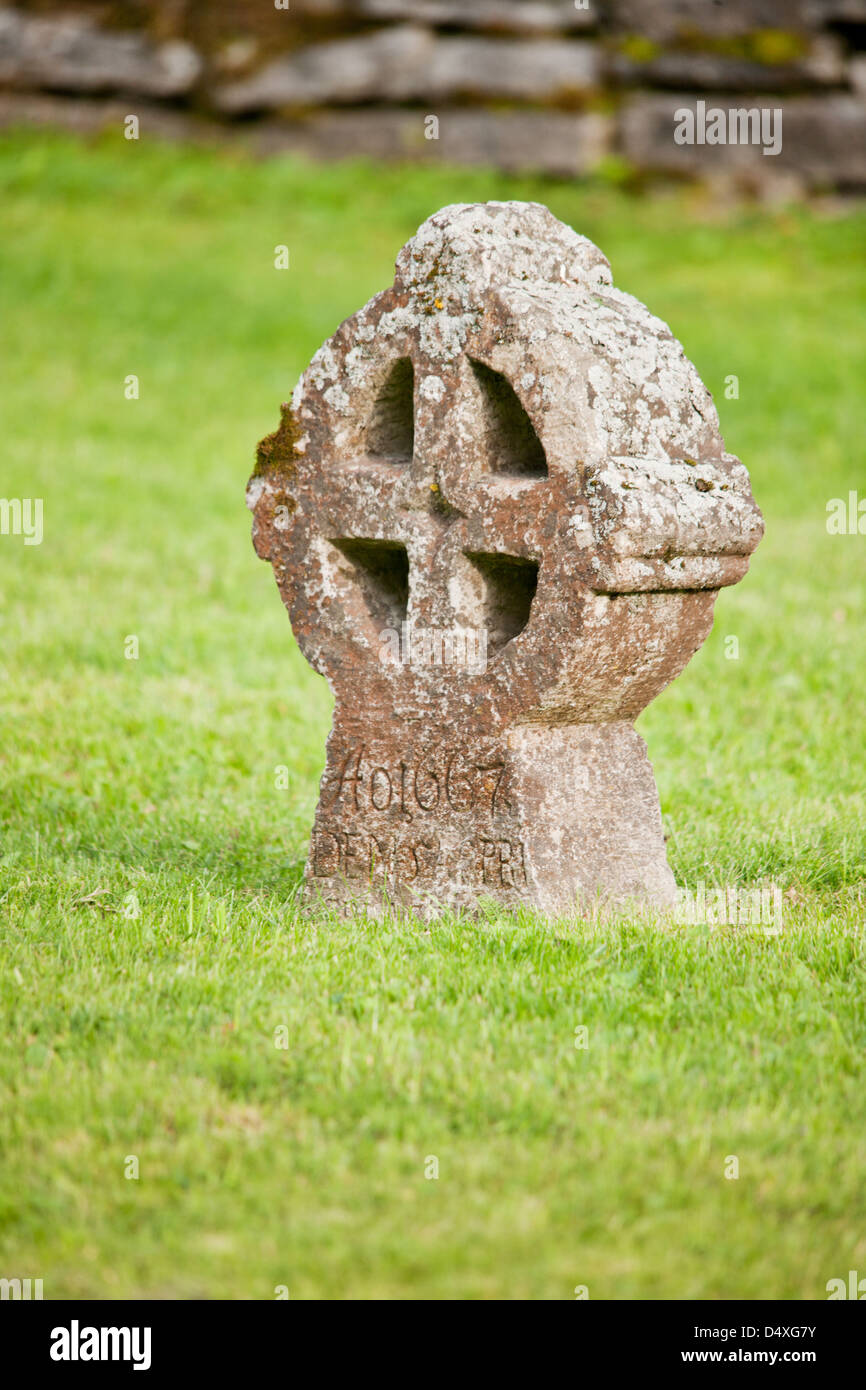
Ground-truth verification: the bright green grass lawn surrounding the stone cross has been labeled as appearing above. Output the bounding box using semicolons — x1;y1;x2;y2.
0;135;866;1298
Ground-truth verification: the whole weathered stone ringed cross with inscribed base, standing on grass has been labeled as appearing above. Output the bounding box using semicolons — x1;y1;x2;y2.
247;203;763;916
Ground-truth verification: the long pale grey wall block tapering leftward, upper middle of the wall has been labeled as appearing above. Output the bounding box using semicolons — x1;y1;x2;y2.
213;25;601;115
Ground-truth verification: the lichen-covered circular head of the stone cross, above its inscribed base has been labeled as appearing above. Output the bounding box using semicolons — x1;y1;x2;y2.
249;203;762;728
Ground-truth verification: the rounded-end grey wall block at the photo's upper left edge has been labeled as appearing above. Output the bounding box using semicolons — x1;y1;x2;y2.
0;8;202;97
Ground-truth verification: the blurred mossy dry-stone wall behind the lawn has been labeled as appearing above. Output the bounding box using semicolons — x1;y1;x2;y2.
0;0;866;193
